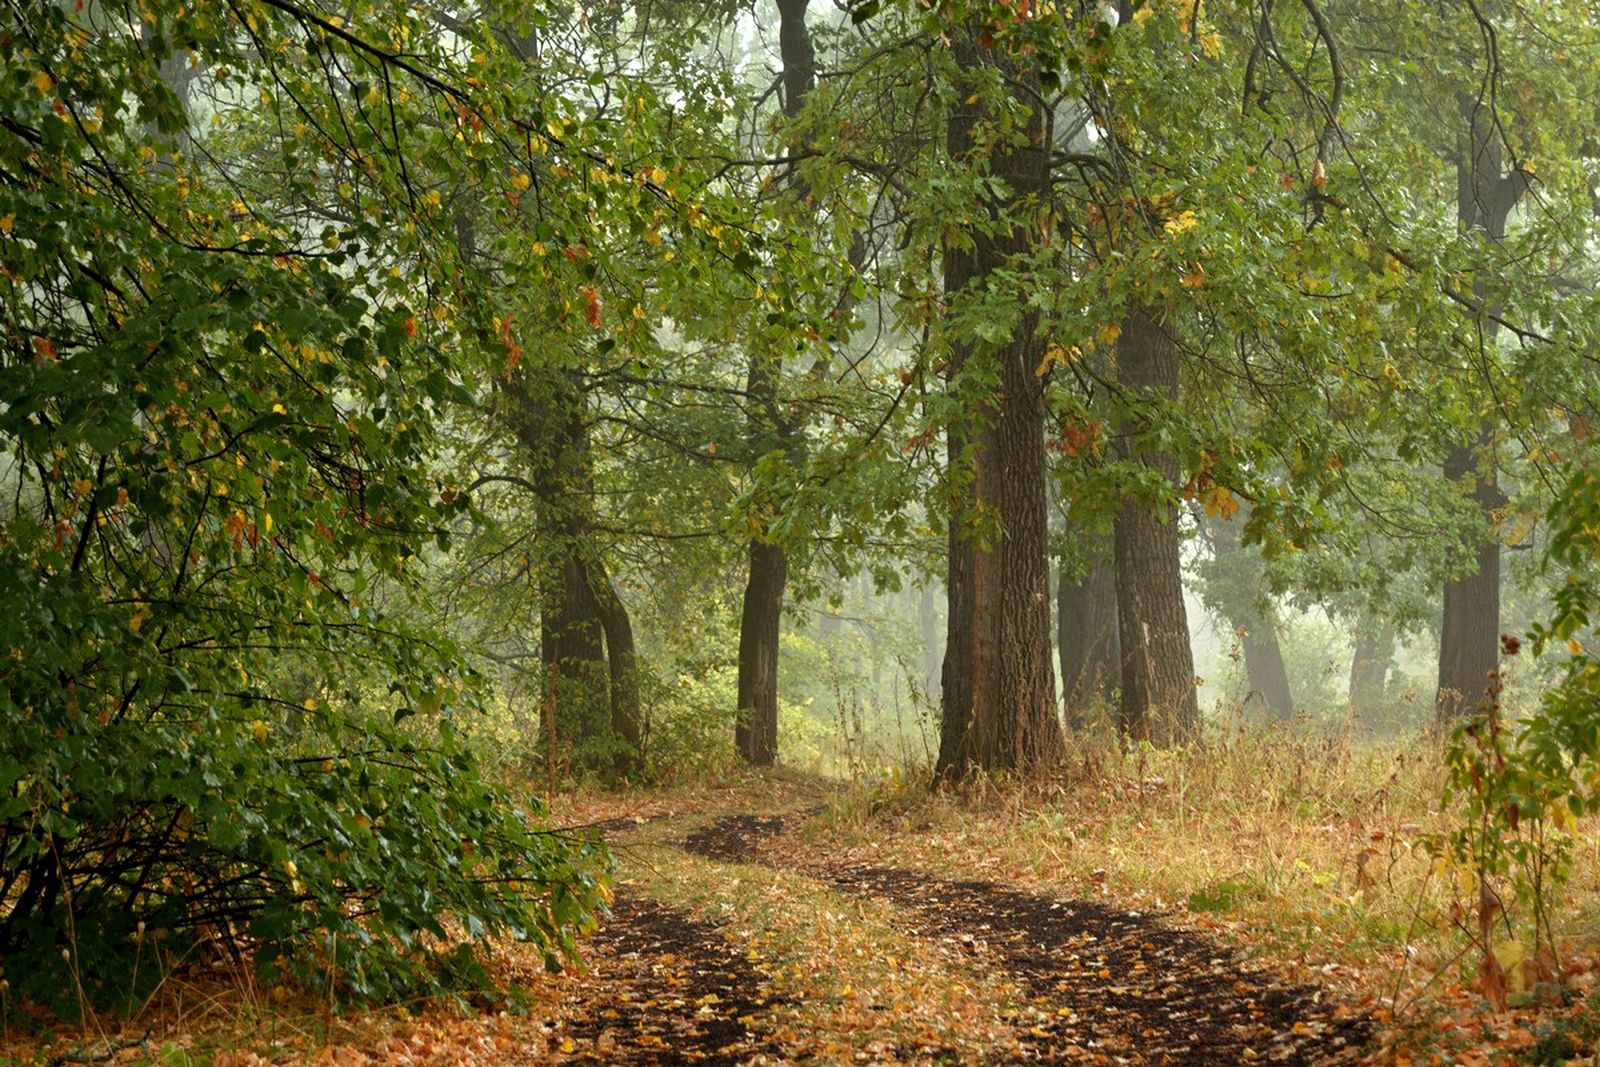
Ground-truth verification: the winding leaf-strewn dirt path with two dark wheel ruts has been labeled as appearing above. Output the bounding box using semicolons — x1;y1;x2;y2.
544;808;1368;1067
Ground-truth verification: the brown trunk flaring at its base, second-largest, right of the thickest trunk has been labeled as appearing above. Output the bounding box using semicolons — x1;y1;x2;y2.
1114;307;1200;747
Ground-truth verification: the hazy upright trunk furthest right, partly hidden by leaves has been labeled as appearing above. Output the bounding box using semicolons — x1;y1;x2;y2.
1434;98;1528;725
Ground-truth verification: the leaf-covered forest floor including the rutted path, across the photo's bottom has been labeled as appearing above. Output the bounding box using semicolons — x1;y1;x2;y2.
9;755;1600;1067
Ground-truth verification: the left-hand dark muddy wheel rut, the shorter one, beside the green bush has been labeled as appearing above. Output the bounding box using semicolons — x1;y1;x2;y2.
560;896;782;1067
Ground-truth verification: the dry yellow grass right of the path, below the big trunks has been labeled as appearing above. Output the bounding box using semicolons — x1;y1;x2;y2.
811;731;1600;1049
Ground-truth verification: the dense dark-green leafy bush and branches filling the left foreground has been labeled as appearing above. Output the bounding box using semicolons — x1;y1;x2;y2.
0;3;605;1005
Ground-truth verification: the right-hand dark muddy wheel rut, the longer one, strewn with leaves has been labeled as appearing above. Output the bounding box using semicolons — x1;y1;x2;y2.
683;814;1370;1067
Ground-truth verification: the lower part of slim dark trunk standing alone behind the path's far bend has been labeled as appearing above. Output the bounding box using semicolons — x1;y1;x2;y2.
734;541;789;766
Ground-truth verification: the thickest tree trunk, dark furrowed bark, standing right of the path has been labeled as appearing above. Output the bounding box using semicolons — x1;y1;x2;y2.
936;37;1062;781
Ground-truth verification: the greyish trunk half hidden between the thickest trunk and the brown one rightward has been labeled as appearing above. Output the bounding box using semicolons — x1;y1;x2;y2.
1056;530;1122;728
